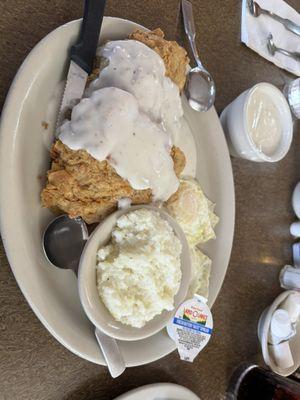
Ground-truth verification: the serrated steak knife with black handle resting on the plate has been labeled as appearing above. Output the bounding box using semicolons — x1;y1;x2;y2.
56;0;106;129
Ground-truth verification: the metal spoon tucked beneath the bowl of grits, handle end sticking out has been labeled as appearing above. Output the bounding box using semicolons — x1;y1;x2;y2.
43;215;126;378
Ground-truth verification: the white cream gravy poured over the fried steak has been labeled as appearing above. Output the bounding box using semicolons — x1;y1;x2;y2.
59;40;196;201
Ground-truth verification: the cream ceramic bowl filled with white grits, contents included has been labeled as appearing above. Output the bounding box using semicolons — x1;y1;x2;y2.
78;205;191;341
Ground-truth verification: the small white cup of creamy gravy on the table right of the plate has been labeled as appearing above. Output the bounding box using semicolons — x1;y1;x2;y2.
220;82;293;162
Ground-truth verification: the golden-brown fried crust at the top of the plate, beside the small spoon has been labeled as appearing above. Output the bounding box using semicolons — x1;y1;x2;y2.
129;28;190;91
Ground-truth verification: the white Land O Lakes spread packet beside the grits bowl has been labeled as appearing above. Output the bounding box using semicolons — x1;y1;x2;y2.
167;295;213;362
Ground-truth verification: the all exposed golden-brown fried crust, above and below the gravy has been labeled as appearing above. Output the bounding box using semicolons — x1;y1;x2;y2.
41;29;189;224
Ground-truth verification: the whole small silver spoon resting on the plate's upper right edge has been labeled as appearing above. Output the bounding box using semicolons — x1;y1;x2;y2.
181;0;216;111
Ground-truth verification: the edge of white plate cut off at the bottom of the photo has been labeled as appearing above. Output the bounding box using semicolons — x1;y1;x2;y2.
115;383;200;400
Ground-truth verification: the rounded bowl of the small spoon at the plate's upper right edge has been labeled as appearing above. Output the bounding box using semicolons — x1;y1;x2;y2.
185;66;216;111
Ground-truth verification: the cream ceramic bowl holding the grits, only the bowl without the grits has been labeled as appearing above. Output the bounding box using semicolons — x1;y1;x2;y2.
78;205;191;340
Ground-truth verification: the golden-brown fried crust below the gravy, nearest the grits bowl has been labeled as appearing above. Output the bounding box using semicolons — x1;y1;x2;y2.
41;140;185;224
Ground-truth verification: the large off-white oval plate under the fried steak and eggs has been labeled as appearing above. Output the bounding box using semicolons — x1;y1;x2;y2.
0;17;234;367
